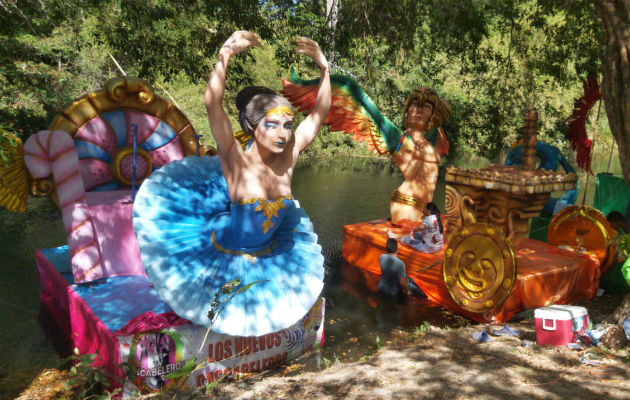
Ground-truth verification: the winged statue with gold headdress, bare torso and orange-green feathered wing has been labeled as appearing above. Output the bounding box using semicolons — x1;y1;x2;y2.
282;70;451;223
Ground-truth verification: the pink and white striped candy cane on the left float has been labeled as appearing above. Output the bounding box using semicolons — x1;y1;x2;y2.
24;131;105;283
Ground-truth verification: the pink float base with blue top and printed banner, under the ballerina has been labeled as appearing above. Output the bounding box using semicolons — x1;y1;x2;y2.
35;246;325;397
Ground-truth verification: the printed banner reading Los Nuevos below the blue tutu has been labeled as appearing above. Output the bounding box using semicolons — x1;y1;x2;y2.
117;297;325;397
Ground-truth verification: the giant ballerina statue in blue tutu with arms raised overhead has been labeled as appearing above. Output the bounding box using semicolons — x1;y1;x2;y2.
133;31;331;336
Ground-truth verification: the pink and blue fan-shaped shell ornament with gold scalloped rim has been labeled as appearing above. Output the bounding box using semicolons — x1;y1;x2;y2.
49;77;204;191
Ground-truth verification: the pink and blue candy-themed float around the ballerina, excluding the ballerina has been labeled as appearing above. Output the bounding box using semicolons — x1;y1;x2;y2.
0;78;324;396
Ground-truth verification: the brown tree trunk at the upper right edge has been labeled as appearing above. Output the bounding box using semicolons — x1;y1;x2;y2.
595;0;630;190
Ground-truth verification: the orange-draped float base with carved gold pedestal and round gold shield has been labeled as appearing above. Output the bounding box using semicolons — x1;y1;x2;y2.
342;108;612;323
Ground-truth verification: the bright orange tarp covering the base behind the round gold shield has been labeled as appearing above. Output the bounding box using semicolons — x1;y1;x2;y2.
342;220;599;323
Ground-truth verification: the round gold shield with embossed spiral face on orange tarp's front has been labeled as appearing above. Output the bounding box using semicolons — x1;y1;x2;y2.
442;223;516;314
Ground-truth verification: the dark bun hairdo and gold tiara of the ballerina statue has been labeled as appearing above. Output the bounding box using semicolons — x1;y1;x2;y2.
236;86;293;136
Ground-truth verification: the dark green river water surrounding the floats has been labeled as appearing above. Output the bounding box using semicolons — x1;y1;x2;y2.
0;152;624;398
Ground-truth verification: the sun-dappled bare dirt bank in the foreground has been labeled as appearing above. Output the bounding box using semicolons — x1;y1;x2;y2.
145;297;630;400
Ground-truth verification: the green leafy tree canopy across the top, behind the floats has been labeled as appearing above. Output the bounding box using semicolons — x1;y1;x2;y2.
0;0;624;173
